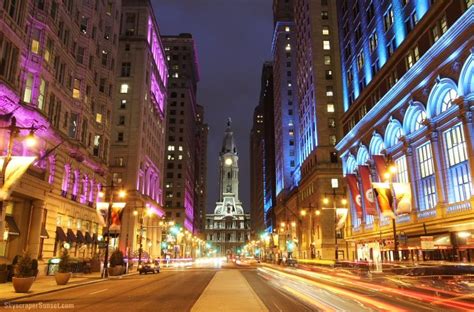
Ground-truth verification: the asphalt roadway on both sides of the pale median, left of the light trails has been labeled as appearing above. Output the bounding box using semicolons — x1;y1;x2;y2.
4;269;314;312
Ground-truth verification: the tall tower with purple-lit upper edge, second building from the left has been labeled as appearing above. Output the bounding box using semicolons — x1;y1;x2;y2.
110;0;168;257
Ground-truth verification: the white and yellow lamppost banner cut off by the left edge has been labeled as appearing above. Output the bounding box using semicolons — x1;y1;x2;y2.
0;156;36;200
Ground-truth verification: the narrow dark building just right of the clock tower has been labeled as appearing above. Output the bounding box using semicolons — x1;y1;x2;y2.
250;105;266;238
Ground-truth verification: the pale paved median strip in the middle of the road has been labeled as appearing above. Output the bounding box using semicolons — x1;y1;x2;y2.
191;270;268;312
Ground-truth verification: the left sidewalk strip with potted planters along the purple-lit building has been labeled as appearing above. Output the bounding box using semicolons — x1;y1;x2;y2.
0;272;138;302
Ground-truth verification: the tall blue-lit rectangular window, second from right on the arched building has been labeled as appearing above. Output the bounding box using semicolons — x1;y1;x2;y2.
416;142;437;210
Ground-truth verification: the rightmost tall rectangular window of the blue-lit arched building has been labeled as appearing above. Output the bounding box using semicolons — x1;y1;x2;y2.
444;123;472;202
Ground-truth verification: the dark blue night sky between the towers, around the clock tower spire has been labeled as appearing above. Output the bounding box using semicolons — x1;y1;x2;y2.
151;0;273;212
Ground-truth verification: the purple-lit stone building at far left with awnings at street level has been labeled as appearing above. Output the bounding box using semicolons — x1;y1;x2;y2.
0;0;121;274
